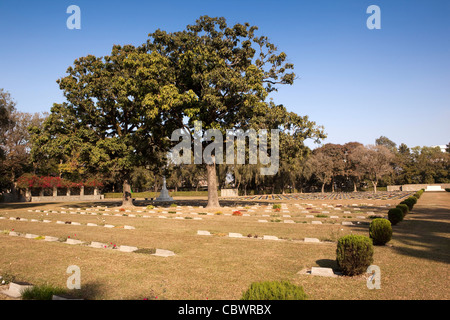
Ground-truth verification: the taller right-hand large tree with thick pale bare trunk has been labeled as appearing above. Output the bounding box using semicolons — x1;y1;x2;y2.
145;16;326;207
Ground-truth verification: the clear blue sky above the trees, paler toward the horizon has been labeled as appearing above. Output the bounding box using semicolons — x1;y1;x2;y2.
0;0;450;147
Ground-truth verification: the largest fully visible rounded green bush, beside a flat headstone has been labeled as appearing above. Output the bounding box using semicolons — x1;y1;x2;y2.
336;235;373;276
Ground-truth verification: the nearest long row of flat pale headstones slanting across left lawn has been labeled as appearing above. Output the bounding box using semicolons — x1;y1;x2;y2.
5;231;175;257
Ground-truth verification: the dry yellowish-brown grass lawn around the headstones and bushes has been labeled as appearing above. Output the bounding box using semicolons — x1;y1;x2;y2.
0;193;450;300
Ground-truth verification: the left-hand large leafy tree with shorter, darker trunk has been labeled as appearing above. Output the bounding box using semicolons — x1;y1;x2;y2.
30;45;193;206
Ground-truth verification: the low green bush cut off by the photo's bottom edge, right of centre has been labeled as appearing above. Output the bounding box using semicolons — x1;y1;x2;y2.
241;281;307;300
